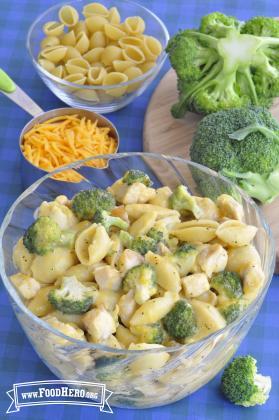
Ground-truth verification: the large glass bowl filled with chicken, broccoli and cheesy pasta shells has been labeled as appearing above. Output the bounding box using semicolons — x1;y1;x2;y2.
0;153;275;408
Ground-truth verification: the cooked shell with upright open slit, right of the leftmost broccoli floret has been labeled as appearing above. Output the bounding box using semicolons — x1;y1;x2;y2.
75;224;112;265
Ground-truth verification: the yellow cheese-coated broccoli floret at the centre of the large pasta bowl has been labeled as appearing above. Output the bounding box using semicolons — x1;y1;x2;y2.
123;264;157;305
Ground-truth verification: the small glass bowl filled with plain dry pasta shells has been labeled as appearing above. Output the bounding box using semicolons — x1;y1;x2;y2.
27;0;169;113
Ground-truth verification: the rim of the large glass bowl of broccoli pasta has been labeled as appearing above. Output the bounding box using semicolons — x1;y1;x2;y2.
0;152;276;355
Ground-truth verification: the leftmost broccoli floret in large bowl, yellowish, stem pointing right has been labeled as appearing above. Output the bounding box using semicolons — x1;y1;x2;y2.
23;216;75;255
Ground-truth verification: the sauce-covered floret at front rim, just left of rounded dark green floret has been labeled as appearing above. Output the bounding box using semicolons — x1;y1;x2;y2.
130;322;167;344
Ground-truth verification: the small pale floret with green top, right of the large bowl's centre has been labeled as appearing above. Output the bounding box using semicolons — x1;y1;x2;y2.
168;243;198;276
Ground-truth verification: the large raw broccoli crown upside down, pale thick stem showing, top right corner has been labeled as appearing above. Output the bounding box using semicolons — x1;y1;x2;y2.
167;12;279;118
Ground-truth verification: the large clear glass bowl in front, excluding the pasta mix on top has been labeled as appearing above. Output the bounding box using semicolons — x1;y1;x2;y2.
0;153;275;408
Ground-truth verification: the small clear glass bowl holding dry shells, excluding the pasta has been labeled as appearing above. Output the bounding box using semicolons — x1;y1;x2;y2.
27;0;169;114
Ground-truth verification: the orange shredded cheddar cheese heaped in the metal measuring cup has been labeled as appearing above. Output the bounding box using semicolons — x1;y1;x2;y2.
21;115;117;182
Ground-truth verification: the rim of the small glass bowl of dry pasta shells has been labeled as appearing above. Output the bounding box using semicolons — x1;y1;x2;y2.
26;0;170;91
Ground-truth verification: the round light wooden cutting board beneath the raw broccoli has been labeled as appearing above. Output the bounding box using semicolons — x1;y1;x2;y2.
143;70;279;273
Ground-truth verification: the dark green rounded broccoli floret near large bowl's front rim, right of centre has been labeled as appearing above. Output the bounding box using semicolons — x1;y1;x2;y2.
163;299;197;340
